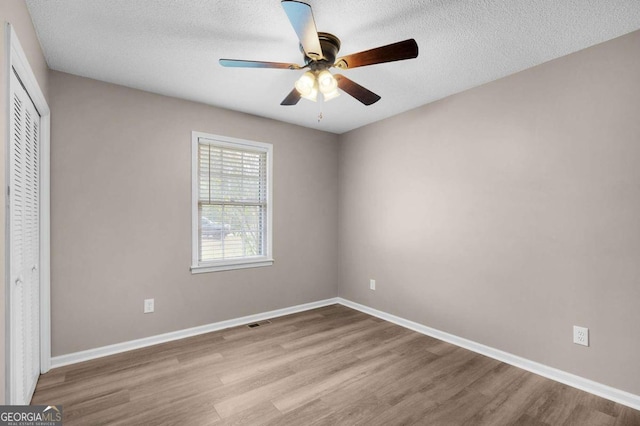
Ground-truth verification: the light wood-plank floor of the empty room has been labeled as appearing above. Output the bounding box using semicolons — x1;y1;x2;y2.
32;305;640;426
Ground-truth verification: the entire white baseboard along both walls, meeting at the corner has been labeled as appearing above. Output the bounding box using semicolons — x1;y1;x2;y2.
51;297;640;410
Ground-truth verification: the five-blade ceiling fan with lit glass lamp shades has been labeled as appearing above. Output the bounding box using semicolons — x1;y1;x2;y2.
219;0;418;105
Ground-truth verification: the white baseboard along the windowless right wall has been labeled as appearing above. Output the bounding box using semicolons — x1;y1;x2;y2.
338;297;640;410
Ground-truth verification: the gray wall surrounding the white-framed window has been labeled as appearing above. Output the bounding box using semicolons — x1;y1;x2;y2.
49;71;338;356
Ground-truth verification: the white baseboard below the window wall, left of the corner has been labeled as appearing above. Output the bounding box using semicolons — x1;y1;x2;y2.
51;297;338;368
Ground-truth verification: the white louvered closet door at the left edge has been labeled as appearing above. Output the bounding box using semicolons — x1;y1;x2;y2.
9;69;40;404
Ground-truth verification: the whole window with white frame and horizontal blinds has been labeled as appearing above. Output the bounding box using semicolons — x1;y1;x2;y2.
191;132;273;273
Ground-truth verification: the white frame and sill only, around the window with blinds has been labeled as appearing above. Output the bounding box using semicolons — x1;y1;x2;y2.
191;131;274;274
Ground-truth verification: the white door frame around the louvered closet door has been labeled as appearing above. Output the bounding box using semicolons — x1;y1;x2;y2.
4;22;51;400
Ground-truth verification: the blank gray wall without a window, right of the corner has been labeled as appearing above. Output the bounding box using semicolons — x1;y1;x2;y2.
339;32;640;395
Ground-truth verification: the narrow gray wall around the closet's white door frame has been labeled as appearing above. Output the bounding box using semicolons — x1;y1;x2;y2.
0;0;48;403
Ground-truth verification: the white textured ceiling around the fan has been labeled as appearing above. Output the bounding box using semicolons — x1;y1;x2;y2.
27;0;640;133
